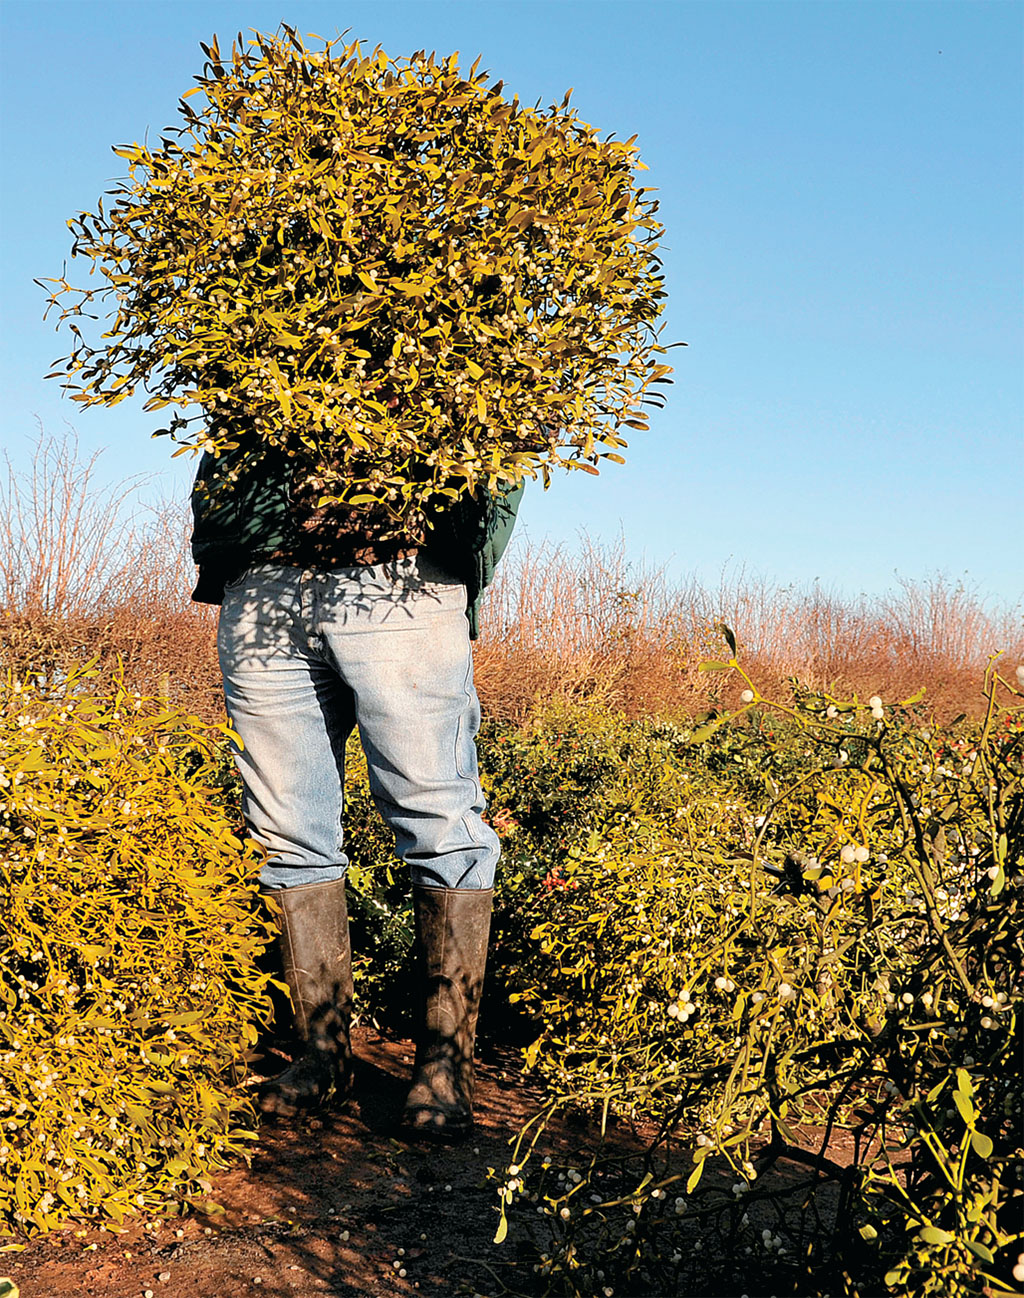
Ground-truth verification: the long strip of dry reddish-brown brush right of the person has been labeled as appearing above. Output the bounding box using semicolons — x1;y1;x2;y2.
476;541;1024;720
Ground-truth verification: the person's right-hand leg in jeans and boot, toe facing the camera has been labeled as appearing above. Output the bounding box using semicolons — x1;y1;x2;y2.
321;559;500;1140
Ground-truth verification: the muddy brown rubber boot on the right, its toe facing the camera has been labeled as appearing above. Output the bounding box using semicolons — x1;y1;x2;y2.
402;885;493;1141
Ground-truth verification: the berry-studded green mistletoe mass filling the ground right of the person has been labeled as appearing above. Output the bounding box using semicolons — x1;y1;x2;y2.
492;662;1024;1295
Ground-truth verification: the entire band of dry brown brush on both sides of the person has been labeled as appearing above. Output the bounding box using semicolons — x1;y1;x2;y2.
0;434;1024;720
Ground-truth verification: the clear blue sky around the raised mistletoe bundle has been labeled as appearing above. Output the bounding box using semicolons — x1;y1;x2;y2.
0;0;1024;601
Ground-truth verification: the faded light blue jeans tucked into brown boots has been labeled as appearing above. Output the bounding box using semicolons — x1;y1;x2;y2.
217;556;498;889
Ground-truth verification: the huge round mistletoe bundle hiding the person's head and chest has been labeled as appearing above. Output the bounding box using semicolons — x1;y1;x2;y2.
40;25;671;522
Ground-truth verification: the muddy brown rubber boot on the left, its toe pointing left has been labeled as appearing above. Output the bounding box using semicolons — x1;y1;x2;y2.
256;879;352;1118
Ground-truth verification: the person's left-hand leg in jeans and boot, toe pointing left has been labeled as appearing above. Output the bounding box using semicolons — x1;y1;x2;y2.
218;566;353;1116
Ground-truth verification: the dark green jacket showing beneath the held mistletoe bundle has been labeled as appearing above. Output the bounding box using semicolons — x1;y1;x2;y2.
192;450;523;640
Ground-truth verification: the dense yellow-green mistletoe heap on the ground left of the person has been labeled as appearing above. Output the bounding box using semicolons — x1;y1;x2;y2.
0;667;270;1231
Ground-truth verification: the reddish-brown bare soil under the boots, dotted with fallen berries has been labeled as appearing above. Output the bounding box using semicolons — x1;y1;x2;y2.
0;1028;861;1298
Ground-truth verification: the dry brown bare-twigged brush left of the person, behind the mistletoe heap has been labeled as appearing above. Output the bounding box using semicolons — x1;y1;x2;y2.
0;431;223;719
